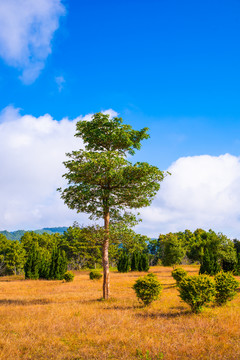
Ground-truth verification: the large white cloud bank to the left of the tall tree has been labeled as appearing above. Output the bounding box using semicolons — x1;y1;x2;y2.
0;107;116;230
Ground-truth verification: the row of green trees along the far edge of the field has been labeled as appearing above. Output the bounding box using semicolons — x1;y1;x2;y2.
0;222;240;278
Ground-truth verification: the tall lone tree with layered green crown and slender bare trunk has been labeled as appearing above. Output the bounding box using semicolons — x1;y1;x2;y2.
59;113;164;299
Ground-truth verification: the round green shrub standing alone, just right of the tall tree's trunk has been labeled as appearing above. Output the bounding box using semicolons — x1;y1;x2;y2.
133;273;162;306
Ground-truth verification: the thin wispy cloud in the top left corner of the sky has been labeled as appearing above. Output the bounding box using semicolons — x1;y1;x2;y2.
0;0;65;84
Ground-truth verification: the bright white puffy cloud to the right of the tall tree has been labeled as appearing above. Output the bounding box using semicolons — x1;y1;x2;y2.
138;154;240;237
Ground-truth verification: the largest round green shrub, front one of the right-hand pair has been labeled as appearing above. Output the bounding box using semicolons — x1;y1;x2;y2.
178;275;216;313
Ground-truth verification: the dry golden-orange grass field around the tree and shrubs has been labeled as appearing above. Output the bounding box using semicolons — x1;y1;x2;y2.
0;266;240;360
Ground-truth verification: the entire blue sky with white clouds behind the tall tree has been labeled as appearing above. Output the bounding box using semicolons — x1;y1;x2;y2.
0;0;240;238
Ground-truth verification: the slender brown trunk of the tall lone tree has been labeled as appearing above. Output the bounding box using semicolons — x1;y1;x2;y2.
102;212;110;299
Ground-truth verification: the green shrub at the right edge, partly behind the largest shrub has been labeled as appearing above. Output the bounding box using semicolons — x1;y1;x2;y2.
215;271;239;306
